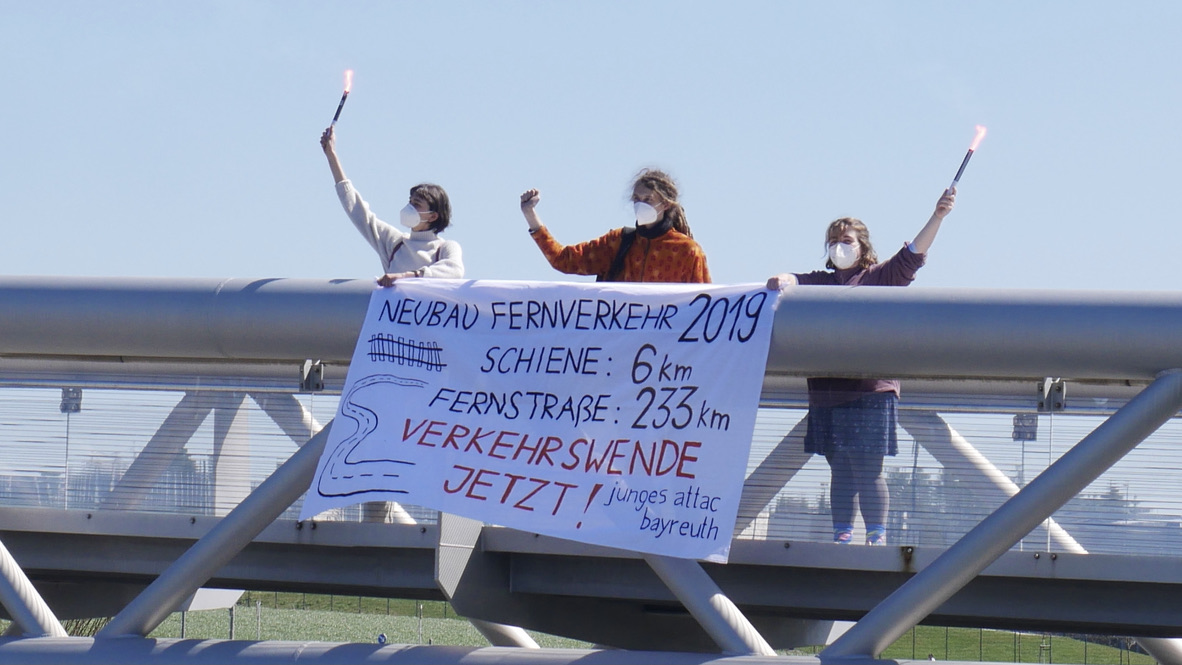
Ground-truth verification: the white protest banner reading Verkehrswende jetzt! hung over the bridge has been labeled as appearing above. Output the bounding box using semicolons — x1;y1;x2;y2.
300;280;777;561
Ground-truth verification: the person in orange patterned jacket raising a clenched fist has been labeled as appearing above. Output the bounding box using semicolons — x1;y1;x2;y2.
521;169;710;283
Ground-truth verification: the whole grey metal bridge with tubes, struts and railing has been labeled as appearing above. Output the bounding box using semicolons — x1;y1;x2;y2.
0;272;1182;665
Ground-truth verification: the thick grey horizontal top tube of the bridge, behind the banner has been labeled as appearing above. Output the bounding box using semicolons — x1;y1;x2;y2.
0;276;1182;382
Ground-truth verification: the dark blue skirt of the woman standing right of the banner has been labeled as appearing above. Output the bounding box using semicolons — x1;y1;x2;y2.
805;392;898;455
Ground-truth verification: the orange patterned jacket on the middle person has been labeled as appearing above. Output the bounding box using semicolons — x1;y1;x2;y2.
531;227;710;283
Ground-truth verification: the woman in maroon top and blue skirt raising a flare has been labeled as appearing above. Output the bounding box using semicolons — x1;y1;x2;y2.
767;188;956;545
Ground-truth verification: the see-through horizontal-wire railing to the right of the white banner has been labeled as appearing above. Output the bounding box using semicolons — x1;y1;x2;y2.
736;382;1182;556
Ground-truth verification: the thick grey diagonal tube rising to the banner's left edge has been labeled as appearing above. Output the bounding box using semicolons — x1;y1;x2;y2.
97;422;332;638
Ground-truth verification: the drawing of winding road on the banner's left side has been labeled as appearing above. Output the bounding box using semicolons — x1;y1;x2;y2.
316;374;427;496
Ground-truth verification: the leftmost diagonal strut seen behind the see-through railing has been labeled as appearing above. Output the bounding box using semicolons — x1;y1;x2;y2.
99;392;217;510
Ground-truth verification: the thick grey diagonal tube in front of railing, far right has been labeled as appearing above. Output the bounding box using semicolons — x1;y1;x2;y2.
820;370;1182;660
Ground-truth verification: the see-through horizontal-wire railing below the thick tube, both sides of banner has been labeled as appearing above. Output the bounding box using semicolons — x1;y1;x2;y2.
0;373;1182;556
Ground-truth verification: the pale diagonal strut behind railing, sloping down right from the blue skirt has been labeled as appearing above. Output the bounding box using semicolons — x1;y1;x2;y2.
898;409;1087;554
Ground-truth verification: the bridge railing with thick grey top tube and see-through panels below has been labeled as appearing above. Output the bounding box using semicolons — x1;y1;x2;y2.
0;278;1182;555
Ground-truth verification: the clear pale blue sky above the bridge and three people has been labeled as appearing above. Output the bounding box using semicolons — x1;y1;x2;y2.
0;1;1182;289
